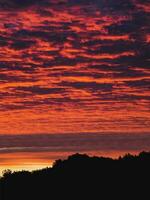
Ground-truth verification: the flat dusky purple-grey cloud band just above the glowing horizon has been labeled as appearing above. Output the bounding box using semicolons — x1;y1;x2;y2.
0;133;150;153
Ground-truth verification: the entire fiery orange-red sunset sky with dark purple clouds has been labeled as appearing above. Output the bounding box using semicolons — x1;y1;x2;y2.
0;0;150;174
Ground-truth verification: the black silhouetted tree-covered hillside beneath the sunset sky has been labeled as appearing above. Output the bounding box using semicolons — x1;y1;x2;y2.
0;152;150;200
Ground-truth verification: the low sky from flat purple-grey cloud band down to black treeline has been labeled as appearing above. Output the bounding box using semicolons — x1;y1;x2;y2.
0;133;150;174
